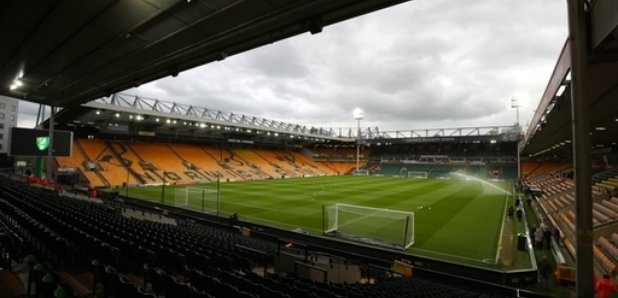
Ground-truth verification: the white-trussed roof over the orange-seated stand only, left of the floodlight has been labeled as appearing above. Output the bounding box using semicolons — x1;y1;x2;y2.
67;94;354;143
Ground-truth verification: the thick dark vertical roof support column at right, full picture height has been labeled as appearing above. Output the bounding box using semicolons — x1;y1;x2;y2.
568;0;594;297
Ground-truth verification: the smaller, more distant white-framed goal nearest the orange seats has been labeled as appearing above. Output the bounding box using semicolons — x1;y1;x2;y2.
174;187;219;213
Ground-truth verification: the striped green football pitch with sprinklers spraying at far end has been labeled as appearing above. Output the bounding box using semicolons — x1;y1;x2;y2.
122;176;511;267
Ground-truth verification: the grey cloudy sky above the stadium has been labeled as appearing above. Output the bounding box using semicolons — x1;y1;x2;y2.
20;0;567;131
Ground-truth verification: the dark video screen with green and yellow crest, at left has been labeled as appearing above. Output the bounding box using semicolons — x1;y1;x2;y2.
9;127;73;156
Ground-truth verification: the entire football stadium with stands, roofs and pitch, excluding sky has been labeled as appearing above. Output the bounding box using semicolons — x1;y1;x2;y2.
0;0;618;298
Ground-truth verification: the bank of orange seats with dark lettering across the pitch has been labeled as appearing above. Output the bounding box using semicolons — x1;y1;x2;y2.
56;139;336;187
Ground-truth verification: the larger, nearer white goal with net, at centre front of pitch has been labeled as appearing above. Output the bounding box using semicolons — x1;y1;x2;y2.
322;203;414;250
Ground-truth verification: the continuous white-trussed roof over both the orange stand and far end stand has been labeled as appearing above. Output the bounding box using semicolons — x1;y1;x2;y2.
54;94;517;144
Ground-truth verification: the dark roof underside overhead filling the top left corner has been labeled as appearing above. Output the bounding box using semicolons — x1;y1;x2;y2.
0;0;405;107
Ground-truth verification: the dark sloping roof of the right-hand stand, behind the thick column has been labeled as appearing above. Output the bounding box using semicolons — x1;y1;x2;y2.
522;35;618;160
